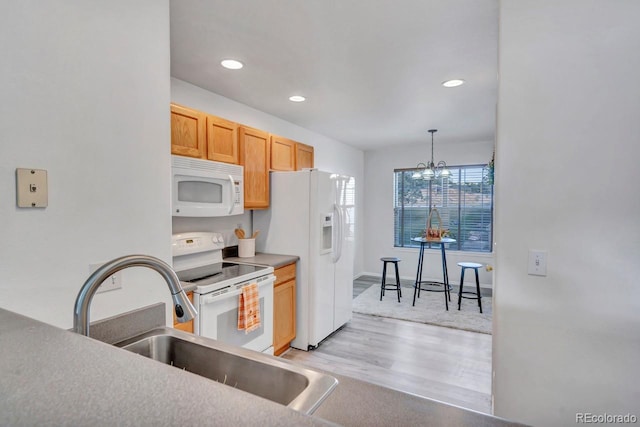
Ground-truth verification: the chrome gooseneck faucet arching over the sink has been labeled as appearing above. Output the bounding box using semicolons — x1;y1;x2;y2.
73;255;198;336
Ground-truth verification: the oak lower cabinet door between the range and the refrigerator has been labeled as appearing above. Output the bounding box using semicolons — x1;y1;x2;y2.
273;279;296;356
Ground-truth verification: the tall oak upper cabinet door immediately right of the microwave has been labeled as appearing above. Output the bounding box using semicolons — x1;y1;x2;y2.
238;126;270;209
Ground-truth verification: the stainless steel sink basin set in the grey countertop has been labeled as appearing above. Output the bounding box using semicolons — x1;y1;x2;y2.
116;328;338;414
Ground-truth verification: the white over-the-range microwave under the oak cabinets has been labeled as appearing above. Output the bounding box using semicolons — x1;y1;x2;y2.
171;155;244;217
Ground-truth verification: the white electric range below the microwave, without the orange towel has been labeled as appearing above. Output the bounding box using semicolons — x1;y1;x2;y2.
171;232;275;354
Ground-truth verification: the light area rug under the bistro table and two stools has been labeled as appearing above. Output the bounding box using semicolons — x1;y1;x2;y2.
353;285;492;334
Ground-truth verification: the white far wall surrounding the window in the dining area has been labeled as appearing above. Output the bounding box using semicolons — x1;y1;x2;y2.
364;141;493;286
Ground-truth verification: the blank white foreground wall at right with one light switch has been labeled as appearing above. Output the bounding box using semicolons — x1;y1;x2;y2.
493;0;640;426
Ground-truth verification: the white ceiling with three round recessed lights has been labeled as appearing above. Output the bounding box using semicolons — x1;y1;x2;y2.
171;0;498;150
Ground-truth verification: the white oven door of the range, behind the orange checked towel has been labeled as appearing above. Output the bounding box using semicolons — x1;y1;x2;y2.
194;275;275;354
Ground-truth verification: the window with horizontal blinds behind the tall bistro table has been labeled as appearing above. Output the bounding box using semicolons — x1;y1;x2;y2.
393;165;493;252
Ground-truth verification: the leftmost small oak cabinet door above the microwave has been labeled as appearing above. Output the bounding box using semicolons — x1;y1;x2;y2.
171;104;207;158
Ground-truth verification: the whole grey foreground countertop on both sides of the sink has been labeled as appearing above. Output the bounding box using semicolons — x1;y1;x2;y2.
0;309;520;426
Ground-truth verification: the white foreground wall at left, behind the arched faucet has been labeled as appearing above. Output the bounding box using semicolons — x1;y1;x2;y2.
0;0;171;328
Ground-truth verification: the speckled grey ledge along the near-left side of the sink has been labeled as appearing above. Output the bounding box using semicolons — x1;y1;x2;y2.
0;309;332;426
